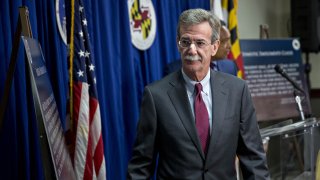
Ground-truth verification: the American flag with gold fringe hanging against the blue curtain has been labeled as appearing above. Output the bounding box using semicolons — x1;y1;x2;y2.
69;0;106;179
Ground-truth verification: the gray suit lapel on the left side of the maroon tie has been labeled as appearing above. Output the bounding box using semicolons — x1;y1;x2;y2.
168;71;205;159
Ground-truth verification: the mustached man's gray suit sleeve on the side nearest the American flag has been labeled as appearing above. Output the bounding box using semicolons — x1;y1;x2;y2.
127;87;157;179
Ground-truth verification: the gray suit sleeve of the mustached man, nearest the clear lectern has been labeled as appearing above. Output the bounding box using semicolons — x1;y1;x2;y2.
237;84;270;180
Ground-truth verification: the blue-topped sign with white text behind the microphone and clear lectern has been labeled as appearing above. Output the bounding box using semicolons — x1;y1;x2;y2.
240;39;311;121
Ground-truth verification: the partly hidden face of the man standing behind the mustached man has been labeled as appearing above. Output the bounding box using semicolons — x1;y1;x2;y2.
213;26;231;60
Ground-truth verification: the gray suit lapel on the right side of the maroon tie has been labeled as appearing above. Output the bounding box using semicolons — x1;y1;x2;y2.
208;71;229;157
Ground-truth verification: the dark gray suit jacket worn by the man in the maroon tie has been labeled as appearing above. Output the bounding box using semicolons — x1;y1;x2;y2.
127;70;269;180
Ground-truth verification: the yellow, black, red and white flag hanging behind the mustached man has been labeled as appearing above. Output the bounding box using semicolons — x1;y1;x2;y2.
211;0;244;78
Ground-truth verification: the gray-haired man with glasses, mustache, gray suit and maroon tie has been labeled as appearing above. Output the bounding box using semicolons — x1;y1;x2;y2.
127;9;269;180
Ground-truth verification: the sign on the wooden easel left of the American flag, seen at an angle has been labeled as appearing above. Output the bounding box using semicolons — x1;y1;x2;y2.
22;37;75;180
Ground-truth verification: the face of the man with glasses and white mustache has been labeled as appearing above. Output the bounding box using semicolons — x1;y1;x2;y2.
177;22;219;81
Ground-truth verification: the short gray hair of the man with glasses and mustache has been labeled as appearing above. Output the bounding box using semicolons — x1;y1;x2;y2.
177;9;221;43
